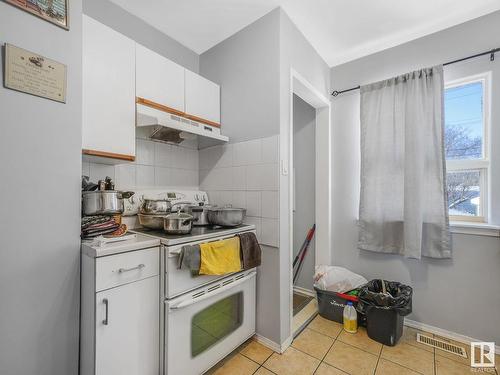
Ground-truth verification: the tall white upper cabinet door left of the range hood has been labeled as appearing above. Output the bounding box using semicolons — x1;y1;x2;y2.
82;16;135;160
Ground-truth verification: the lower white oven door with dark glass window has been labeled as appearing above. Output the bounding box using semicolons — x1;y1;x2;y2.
165;270;256;375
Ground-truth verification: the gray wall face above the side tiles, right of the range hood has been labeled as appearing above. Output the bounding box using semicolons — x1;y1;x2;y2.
200;9;280;143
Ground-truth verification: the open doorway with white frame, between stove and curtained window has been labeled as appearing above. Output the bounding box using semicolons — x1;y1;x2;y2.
288;69;332;342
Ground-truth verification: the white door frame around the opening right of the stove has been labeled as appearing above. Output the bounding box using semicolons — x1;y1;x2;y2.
286;68;332;344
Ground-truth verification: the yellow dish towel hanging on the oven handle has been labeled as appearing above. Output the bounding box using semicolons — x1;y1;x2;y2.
200;237;241;275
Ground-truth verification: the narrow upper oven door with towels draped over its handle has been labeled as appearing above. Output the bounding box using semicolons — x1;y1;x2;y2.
165;231;255;298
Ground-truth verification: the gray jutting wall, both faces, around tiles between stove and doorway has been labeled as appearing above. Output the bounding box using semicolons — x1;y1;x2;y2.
200;8;330;344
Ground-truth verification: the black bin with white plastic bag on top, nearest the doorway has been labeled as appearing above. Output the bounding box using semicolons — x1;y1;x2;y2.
314;287;366;326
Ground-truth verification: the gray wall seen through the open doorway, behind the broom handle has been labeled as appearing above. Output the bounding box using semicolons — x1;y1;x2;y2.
293;95;316;291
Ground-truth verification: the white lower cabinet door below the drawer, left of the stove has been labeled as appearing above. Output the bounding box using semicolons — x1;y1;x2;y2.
95;276;160;375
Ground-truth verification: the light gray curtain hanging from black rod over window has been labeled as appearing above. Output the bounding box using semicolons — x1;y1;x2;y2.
358;66;451;259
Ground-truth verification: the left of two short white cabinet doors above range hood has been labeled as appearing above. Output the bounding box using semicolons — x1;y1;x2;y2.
136;44;184;112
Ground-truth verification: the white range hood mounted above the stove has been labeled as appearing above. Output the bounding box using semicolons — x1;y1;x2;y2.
136;103;229;145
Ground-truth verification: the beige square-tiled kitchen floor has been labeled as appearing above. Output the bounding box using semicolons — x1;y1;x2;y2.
209;316;500;375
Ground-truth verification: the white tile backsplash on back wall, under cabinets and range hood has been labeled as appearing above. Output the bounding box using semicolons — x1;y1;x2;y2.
82;138;199;189
